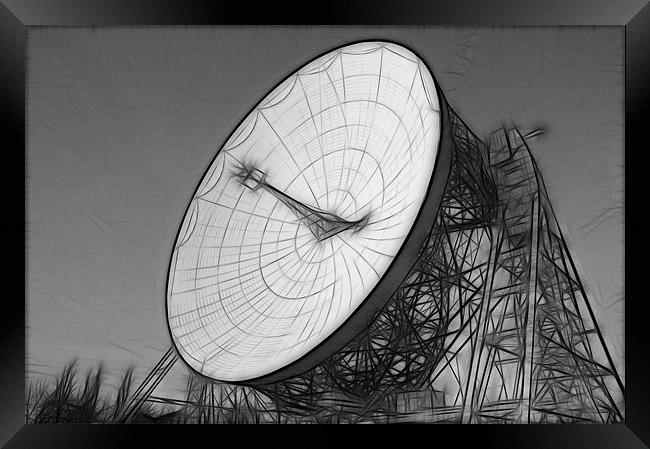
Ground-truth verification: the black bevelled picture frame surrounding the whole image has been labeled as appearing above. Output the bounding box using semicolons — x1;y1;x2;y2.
6;0;650;449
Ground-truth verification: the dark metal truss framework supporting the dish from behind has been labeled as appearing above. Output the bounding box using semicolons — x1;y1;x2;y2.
128;102;624;423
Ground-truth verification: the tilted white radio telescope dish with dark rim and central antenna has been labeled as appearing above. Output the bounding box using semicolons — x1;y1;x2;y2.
166;42;450;383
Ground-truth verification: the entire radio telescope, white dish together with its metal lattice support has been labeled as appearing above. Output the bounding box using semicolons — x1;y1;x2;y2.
127;42;624;423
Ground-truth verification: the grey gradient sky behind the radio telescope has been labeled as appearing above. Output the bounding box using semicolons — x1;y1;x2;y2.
27;27;624;394
